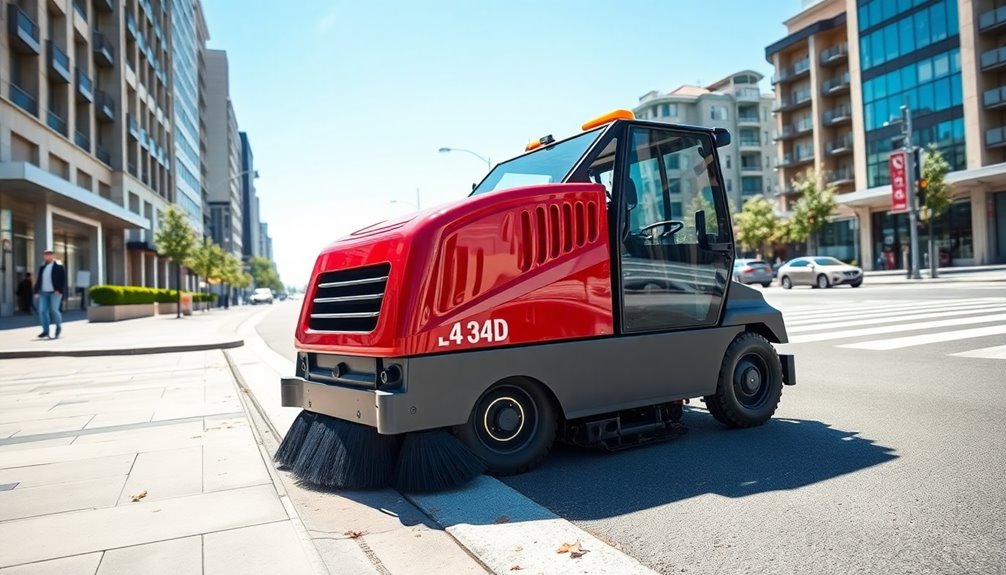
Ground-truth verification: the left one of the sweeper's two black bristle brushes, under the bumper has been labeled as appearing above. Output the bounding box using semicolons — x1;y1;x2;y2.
293;414;398;490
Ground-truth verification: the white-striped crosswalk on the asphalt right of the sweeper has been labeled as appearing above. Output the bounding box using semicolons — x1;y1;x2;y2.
783;297;1006;359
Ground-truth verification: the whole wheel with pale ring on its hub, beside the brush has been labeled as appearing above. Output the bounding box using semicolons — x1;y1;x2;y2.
455;379;556;475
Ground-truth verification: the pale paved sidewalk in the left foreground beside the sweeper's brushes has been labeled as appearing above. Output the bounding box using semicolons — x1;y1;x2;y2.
0;347;327;575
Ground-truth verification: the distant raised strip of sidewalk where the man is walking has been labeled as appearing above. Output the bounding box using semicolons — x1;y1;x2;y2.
0;306;251;359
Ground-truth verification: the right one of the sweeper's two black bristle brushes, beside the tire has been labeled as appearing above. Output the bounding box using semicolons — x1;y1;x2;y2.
395;429;486;494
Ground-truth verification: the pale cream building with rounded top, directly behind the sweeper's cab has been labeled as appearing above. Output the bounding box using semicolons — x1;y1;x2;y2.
633;70;779;210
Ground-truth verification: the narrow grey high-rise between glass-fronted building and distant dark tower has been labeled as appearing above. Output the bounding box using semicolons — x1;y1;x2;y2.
205;49;243;257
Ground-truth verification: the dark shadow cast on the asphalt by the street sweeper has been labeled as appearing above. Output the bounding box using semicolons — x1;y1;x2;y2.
503;409;897;521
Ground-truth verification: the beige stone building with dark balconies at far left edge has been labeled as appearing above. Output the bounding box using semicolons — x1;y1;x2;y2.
0;0;181;315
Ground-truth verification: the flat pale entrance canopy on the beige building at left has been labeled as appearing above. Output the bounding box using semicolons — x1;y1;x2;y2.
0;162;150;229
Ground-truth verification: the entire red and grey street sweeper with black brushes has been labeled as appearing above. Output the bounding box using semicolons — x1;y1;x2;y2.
277;111;795;491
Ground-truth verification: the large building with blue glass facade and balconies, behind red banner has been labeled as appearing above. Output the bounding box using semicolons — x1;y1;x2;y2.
766;0;1006;269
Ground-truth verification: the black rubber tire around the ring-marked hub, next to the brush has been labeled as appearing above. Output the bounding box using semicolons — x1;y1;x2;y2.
454;378;558;475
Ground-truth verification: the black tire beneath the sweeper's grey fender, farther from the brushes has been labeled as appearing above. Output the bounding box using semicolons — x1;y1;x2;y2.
703;332;783;427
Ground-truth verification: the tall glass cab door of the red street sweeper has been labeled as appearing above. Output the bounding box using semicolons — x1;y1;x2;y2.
613;125;733;333
